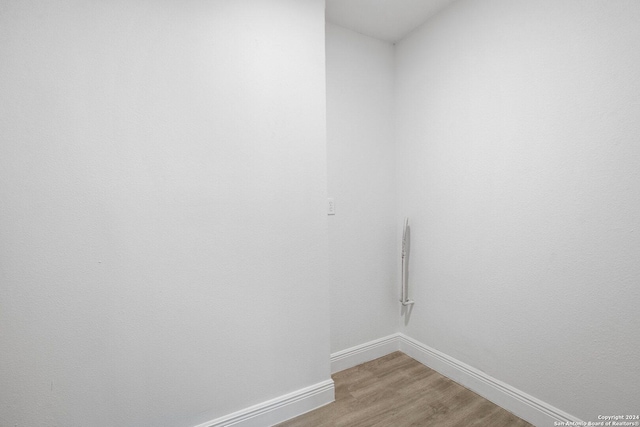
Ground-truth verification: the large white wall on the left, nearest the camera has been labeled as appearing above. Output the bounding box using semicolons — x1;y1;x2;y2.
0;0;329;426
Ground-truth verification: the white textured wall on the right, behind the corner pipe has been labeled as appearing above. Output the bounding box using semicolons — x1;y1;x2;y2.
396;0;640;421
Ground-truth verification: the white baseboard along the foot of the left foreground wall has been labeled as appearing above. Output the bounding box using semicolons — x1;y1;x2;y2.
196;380;334;427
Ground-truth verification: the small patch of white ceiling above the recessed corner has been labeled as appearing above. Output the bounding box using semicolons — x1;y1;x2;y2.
326;0;455;43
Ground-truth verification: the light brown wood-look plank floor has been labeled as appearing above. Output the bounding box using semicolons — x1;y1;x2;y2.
278;352;532;427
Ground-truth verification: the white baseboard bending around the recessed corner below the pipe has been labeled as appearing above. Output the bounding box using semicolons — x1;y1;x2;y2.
331;333;582;427
